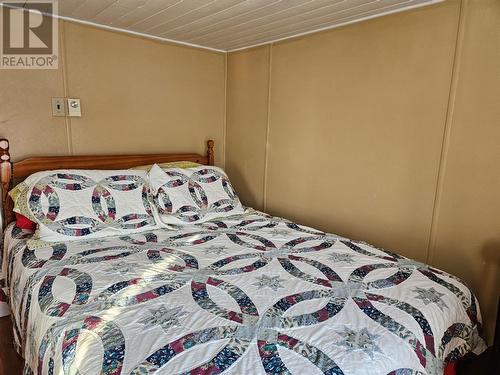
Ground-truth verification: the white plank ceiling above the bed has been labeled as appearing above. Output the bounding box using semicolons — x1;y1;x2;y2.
18;0;442;51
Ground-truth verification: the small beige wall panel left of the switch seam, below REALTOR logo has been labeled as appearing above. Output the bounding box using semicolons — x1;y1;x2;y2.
0;20;68;161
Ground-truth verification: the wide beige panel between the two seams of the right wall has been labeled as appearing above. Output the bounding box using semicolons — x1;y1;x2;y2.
267;1;459;260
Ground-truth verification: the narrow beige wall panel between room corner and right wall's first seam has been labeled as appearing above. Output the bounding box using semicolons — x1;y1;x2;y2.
226;46;269;209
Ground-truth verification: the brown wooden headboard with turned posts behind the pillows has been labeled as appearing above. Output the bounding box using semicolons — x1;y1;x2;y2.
0;139;215;225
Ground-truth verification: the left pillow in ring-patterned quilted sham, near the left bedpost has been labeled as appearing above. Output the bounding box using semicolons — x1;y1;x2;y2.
9;170;157;242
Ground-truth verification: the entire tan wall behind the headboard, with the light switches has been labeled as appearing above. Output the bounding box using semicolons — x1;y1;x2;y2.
0;21;225;165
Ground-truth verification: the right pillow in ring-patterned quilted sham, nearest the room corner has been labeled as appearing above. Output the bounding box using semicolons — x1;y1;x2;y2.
149;164;244;225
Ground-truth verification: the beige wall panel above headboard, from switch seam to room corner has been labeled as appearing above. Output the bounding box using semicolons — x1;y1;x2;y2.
64;23;225;165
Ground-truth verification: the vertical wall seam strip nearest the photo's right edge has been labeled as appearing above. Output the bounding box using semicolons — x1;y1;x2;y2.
426;0;468;264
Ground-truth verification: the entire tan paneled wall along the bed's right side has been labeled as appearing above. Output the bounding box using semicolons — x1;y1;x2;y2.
226;0;500;344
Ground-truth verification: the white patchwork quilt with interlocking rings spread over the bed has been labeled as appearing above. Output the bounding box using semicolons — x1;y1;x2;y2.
3;210;485;375
